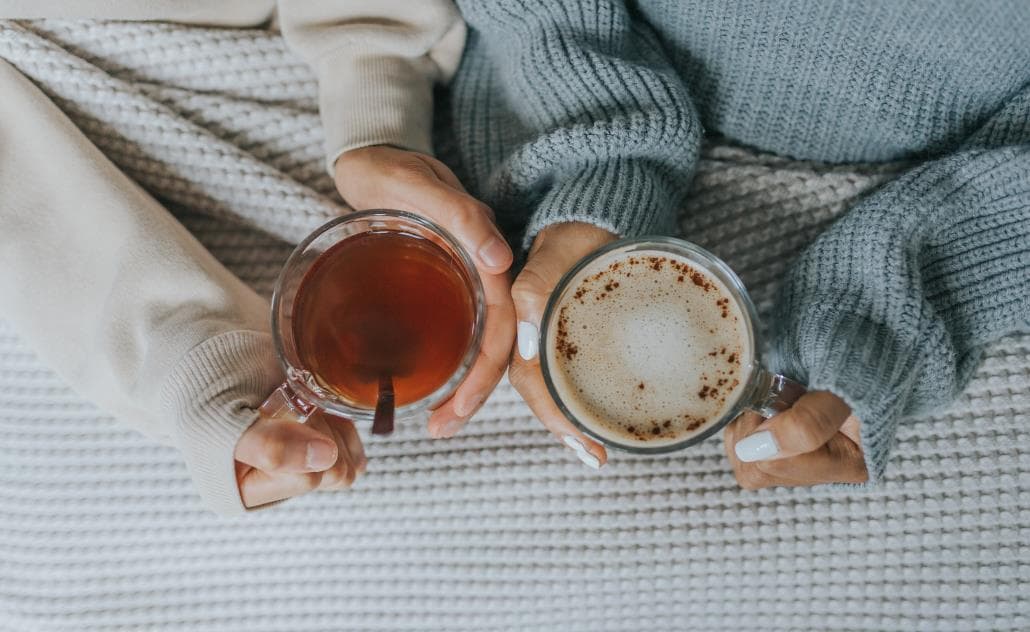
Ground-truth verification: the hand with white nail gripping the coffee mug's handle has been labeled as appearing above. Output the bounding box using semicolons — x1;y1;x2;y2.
723;391;869;489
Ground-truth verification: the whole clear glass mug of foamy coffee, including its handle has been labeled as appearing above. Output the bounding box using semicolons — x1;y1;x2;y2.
540;237;805;454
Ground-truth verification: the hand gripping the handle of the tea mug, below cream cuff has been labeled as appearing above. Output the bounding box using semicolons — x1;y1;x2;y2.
235;411;368;507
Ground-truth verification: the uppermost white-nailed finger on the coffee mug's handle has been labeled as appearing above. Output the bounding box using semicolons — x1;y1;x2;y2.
733;391;851;463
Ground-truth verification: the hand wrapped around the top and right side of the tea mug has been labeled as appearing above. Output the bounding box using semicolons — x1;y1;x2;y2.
336;145;515;438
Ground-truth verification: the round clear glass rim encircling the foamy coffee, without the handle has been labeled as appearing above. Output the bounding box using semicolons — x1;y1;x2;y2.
538;235;762;454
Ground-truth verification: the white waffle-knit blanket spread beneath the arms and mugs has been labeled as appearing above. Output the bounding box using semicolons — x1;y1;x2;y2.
0;23;1030;632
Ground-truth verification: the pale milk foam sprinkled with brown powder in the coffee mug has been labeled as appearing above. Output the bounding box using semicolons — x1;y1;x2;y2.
546;251;752;447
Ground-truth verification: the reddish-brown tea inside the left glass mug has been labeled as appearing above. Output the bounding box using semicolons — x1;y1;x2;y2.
291;231;476;409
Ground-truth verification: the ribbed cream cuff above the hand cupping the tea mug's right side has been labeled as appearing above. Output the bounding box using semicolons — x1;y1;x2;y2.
315;49;433;175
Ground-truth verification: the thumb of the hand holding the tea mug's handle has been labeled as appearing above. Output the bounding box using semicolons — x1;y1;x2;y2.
235;417;339;472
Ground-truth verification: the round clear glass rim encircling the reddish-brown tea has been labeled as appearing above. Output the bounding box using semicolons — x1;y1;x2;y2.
271;209;486;421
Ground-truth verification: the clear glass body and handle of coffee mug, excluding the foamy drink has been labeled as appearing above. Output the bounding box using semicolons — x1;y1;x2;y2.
539;237;805;454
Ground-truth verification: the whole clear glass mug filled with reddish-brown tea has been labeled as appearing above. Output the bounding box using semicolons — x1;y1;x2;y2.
262;210;485;434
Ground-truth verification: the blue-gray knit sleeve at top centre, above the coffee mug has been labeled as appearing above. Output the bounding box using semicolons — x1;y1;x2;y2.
454;0;701;247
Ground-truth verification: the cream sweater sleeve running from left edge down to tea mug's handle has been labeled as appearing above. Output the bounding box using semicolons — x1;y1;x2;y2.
0;63;278;512
